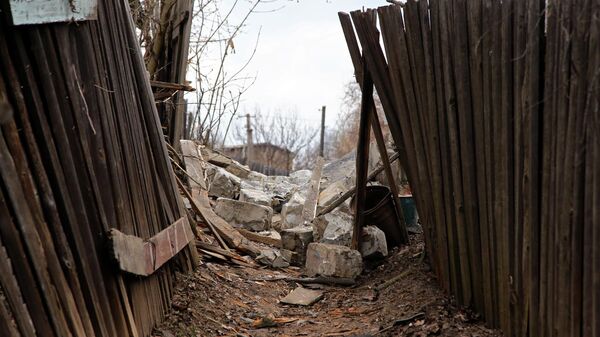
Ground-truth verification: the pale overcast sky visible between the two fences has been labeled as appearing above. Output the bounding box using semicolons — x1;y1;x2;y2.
220;0;386;139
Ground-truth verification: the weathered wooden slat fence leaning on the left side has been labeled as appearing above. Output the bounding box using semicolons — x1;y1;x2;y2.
0;0;192;337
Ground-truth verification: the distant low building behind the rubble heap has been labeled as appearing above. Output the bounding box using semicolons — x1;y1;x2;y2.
223;143;296;175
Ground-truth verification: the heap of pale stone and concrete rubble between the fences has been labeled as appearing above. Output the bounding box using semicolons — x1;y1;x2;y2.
192;148;388;278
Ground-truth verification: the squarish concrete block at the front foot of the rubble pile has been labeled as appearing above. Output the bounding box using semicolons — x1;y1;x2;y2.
306;242;362;279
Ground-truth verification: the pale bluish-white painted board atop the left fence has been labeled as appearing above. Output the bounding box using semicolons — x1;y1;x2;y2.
0;0;98;25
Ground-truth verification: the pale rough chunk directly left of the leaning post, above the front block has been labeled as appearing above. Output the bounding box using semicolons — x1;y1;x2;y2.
313;211;354;246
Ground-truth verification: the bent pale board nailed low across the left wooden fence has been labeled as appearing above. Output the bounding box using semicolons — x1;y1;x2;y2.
109;217;194;276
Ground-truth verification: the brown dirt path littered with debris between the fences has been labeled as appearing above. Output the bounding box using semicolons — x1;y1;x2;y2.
155;234;501;337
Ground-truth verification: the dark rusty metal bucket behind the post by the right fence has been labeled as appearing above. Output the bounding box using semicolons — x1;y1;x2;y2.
352;186;402;249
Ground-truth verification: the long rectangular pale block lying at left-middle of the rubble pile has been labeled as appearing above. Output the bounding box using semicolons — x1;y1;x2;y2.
215;198;273;232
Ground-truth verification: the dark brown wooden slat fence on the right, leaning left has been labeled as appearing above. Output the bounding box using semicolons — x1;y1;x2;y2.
340;0;600;337
